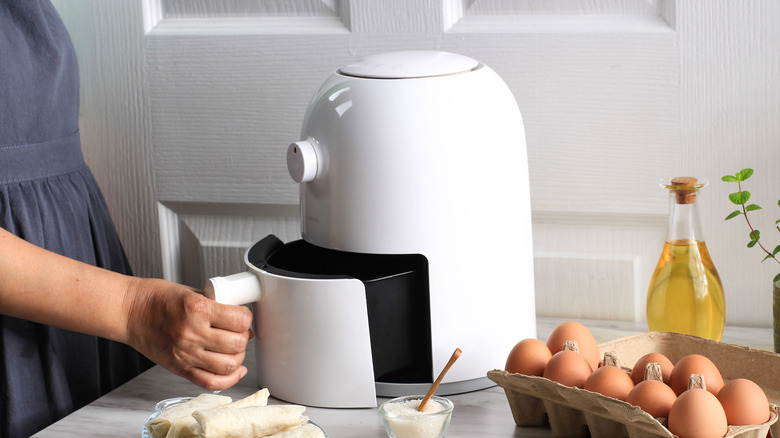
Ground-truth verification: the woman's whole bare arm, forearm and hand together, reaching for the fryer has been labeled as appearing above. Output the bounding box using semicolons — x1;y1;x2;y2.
0;228;252;390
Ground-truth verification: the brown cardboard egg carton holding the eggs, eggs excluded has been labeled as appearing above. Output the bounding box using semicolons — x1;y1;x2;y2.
488;332;780;438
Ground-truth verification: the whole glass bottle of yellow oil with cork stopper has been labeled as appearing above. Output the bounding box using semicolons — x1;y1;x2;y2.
647;177;726;340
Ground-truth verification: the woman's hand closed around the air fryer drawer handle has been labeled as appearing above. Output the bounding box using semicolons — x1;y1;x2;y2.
124;278;252;391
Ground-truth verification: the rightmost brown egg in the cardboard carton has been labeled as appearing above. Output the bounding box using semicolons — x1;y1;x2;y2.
718;379;770;426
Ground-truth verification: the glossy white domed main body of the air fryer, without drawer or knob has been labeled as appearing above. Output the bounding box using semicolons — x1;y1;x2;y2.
292;52;536;386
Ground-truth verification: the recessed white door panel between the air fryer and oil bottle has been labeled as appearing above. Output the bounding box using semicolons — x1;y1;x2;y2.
533;211;668;321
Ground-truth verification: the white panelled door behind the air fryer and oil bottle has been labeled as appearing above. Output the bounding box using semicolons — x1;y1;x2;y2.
55;0;780;325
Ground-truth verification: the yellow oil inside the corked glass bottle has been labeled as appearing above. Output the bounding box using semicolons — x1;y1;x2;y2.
647;241;726;341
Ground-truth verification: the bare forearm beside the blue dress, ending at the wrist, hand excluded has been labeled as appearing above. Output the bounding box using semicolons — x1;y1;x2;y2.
0;228;131;342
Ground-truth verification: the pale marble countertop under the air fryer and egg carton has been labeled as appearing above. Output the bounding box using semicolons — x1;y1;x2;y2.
34;318;772;438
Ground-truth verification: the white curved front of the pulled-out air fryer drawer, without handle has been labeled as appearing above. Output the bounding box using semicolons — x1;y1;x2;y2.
254;266;376;408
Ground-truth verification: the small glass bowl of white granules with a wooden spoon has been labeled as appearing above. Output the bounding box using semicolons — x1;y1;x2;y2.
379;395;454;438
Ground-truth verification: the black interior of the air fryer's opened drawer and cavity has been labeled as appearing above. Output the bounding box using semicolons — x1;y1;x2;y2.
247;235;433;383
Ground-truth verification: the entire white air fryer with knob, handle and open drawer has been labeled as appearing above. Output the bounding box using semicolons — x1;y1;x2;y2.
207;51;536;407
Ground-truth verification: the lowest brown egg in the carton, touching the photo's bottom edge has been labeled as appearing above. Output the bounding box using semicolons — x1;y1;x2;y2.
669;388;729;438
